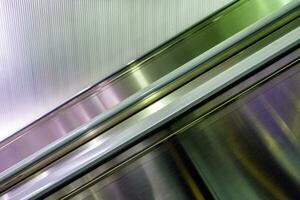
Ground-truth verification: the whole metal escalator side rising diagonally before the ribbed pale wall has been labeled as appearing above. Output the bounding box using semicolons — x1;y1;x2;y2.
0;0;300;199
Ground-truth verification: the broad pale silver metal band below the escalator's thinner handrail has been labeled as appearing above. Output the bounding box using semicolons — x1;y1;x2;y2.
3;25;300;199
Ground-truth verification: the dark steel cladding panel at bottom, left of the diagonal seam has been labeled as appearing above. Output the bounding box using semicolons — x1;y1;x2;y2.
67;143;205;200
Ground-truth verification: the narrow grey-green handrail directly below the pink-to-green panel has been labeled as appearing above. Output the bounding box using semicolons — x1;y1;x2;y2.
0;1;300;186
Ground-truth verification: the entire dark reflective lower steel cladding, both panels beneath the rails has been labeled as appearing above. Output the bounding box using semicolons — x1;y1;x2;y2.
52;52;300;200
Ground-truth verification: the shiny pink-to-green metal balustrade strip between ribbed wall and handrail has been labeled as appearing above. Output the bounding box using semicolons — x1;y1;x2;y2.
0;0;292;175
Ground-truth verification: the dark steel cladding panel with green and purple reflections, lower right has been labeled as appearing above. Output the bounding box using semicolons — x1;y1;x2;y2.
179;64;300;199
